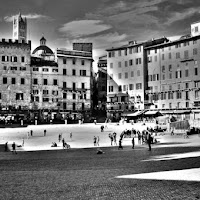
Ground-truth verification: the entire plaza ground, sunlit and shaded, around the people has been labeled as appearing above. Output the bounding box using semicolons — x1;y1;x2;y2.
0;124;200;200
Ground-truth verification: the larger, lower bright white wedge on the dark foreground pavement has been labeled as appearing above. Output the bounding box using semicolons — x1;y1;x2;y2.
116;168;200;182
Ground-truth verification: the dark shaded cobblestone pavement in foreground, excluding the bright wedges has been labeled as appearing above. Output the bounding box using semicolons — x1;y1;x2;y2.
0;144;200;200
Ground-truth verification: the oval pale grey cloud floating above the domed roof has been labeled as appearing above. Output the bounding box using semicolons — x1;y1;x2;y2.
59;20;112;38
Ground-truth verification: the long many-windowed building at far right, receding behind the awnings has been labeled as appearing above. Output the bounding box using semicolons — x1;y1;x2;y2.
146;22;200;119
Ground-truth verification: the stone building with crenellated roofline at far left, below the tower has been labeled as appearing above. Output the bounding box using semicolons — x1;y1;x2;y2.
0;39;31;110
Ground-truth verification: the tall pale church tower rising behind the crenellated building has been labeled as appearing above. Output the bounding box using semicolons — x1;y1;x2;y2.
13;13;27;41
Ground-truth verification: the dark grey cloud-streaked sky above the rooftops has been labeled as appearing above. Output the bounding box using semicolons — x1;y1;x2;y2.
0;0;200;64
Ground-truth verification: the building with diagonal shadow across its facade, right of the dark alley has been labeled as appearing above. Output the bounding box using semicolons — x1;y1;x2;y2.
107;38;168;118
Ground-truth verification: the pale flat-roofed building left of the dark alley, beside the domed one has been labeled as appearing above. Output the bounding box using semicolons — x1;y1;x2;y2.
56;46;93;118
